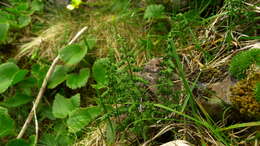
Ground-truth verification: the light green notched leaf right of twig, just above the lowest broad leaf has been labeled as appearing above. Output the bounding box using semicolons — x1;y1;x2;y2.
52;94;80;118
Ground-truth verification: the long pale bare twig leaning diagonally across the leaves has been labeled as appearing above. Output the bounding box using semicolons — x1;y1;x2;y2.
17;27;87;139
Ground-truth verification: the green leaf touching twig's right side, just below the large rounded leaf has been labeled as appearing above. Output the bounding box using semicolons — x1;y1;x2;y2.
48;65;67;89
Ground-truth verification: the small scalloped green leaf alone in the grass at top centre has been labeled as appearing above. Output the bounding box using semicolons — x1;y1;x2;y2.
144;5;164;19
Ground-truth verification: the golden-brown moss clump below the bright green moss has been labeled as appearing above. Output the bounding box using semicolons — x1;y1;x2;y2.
230;72;260;118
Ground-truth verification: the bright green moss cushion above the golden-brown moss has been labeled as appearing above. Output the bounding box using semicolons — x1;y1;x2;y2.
229;49;260;79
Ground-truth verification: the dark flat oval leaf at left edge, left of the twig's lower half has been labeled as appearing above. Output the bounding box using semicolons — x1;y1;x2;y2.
1;93;33;107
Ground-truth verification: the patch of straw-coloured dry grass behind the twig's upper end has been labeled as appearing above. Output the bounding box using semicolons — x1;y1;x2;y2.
17;4;145;62
